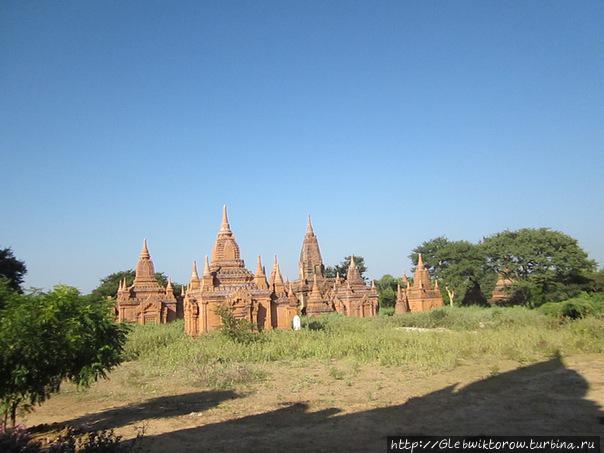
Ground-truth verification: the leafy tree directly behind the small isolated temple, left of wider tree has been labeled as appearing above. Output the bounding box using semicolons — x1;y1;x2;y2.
409;236;495;305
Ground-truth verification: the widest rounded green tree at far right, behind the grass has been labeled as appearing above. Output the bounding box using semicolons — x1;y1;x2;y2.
481;228;596;306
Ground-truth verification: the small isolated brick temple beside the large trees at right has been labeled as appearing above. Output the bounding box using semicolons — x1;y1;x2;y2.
394;253;444;314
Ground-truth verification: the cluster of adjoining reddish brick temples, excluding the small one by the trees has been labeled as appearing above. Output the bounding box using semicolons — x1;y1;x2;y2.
117;206;378;336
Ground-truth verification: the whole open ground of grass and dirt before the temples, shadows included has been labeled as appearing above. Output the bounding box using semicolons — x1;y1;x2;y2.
24;307;604;451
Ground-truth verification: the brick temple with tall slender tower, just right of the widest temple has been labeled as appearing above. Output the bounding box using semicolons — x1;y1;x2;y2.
292;216;378;317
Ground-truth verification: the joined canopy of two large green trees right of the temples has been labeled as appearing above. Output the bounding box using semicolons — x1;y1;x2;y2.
410;228;604;307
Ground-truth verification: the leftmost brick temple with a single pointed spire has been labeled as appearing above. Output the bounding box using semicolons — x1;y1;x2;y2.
116;240;179;324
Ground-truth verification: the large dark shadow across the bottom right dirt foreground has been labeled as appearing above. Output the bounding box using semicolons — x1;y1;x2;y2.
137;357;604;452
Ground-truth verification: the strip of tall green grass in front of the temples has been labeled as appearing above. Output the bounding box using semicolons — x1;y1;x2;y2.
126;307;604;387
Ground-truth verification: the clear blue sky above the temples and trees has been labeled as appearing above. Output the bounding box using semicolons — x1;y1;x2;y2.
0;0;604;291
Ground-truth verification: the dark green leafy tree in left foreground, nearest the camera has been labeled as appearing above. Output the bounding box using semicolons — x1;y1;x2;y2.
0;282;127;426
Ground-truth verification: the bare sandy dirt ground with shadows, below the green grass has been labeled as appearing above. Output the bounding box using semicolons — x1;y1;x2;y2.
21;354;604;452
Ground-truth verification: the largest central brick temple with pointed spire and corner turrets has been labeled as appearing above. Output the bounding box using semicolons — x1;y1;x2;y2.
184;206;298;336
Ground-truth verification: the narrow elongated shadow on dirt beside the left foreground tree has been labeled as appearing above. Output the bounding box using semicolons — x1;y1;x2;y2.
54;390;240;429
